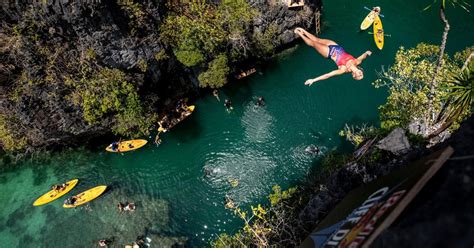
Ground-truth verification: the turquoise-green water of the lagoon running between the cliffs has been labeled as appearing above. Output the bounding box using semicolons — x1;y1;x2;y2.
0;0;474;247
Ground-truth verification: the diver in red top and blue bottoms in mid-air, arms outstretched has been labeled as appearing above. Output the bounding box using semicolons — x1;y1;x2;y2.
295;28;372;86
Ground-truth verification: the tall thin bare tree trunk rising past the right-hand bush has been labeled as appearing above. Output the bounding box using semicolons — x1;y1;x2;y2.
426;6;449;134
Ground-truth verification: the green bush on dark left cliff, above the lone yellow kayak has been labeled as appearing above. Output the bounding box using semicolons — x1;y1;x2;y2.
66;65;152;139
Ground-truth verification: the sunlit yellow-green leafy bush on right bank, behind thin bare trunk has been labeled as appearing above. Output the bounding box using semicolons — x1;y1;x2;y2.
374;43;472;134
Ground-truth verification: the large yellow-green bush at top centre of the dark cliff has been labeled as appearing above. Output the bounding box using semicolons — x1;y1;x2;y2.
161;0;258;88
